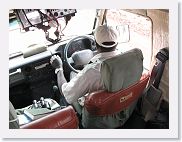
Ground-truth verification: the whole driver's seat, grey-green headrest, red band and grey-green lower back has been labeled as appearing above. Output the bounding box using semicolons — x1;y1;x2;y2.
82;49;149;128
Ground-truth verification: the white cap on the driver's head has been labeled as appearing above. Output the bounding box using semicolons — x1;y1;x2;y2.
94;25;118;48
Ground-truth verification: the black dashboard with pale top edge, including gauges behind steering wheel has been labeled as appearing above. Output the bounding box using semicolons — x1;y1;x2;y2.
9;36;96;109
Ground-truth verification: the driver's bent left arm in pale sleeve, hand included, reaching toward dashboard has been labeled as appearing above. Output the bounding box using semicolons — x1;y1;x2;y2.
50;55;95;104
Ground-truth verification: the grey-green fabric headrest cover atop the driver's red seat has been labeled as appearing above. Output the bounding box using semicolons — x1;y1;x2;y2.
101;48;143;92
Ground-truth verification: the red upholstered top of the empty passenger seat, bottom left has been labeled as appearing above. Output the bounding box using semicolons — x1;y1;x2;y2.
21;106;79;129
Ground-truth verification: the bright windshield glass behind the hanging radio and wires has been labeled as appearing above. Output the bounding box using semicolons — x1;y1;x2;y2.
9;9;96;56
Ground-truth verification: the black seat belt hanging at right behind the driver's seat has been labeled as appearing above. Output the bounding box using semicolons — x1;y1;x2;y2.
141;48;169;121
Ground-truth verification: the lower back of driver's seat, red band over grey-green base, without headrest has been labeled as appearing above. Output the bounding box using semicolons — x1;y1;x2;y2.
82;74;150;128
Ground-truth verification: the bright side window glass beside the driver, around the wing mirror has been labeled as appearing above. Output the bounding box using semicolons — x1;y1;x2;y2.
106;9;152;69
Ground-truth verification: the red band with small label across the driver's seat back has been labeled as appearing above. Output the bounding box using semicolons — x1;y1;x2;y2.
85;74;150;116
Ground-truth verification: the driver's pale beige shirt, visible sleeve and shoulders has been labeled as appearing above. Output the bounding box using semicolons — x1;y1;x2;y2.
62;51;120;104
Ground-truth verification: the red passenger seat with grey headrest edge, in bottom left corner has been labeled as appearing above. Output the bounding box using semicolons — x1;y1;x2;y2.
9;102;79;129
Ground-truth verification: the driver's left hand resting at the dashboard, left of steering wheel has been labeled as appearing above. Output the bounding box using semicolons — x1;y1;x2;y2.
50;55;63;69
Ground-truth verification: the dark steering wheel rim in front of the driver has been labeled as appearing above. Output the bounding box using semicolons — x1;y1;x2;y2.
64;35;95;73
